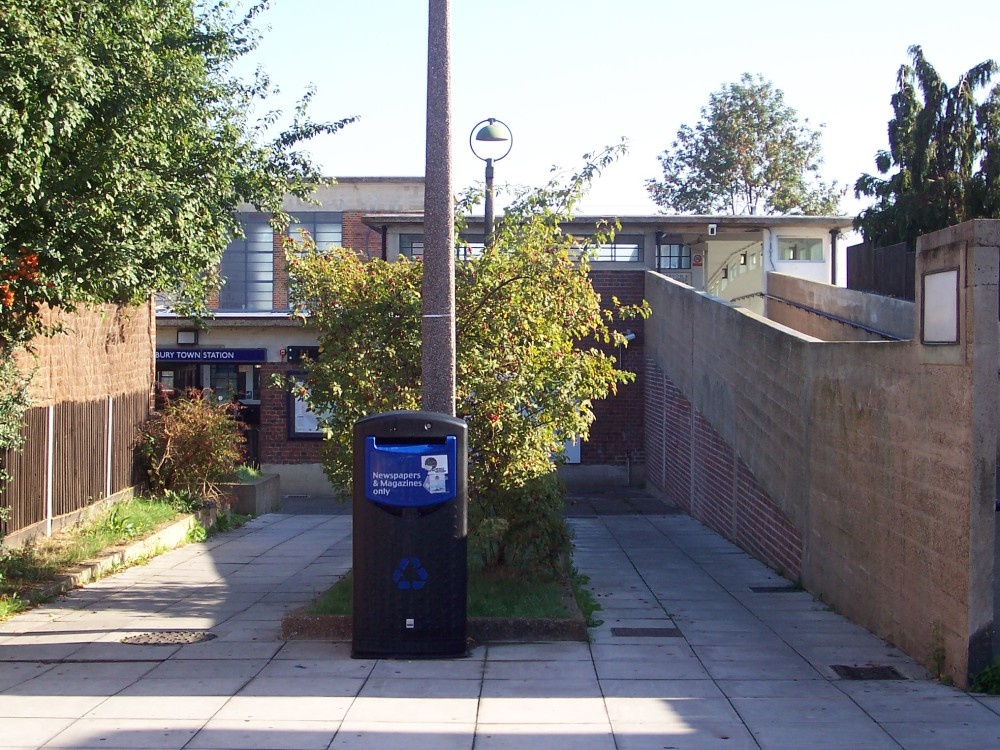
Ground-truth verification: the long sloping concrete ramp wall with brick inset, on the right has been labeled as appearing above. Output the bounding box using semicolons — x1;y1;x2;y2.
646;221;1000;685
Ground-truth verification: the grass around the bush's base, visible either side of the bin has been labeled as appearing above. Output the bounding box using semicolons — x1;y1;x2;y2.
309;567;570;619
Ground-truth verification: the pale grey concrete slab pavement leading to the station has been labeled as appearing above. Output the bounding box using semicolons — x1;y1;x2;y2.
0;514;1000;750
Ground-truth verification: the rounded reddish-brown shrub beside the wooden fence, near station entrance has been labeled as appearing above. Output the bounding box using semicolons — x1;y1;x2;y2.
139;396;245;499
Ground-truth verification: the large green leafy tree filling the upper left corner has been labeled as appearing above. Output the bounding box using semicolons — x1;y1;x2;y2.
0;0;350;347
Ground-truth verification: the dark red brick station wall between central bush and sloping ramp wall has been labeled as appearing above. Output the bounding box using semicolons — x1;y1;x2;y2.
580;269;645;466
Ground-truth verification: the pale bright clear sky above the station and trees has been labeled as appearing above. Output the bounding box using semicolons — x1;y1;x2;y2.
244;0;1000;214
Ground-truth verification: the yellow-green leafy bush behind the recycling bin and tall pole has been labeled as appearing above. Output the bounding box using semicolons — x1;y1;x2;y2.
289;145;646;565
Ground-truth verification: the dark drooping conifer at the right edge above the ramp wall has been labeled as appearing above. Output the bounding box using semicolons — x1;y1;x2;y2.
854;46;1000;247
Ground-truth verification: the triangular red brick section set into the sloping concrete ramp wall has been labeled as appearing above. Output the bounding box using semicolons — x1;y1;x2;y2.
645;361;803;578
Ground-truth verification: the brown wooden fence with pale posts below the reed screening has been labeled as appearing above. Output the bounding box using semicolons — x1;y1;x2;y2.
0;391;149;535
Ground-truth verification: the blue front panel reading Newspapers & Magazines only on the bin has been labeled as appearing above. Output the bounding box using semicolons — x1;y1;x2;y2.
365;435;458;508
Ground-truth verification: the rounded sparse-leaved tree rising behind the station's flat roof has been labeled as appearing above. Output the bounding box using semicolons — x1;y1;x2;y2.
646;73;843;215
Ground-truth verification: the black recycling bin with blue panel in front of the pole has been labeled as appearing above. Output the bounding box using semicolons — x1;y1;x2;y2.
351;411;468;658
